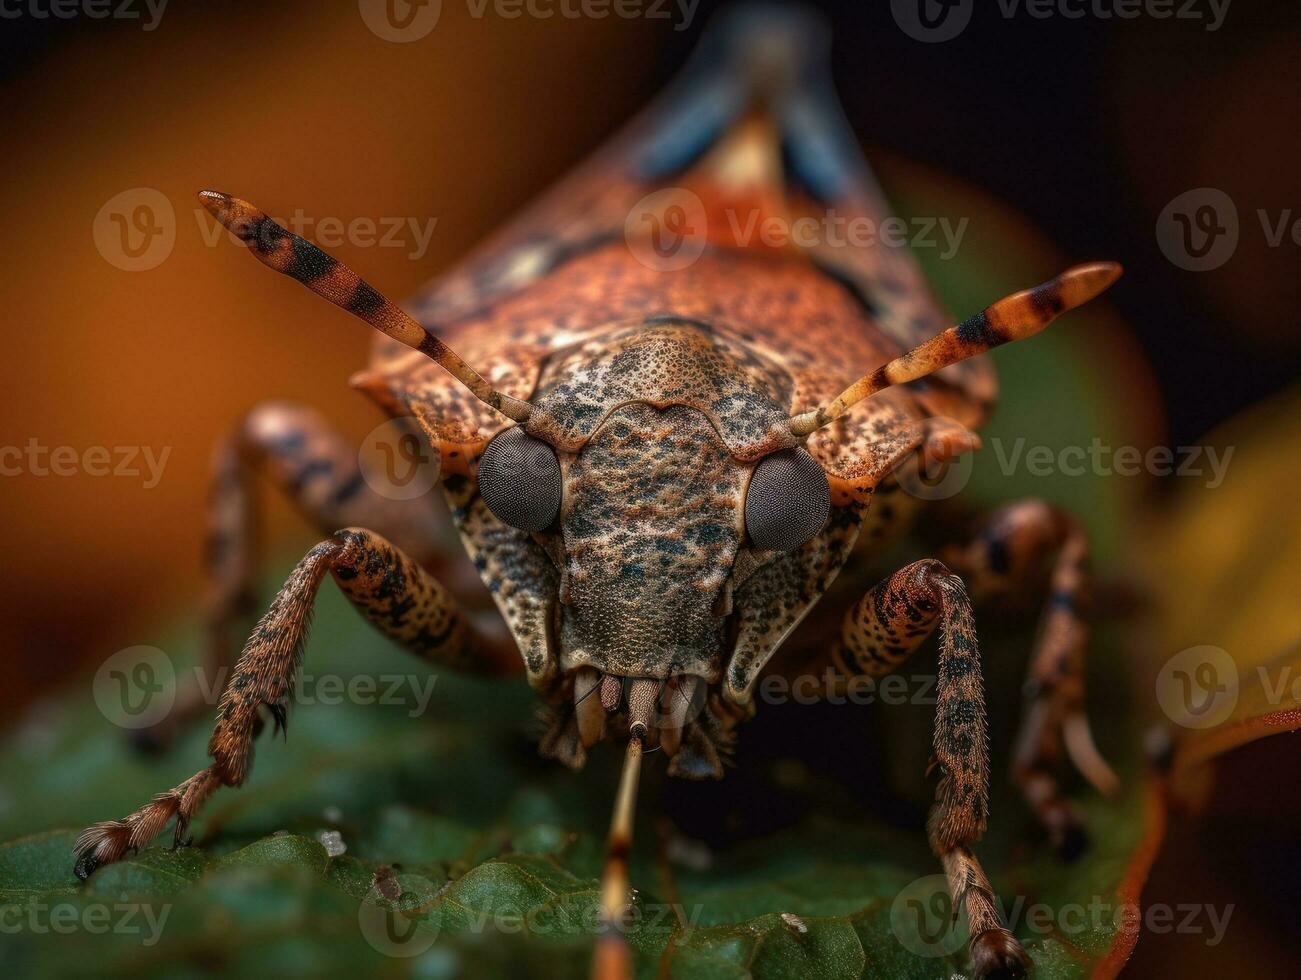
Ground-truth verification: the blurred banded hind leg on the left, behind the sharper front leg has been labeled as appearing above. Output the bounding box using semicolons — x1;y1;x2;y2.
133;402;438;750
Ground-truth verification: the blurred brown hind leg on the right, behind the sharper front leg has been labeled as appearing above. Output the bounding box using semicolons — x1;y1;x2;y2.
943;500;1119;856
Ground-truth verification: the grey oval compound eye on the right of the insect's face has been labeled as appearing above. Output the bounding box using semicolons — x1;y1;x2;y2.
745;449;831;552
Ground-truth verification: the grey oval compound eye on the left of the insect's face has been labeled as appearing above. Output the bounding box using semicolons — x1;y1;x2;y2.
479;426;561;531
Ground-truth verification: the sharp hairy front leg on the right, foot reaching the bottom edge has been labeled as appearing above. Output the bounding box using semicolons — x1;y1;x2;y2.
833;558;1029;977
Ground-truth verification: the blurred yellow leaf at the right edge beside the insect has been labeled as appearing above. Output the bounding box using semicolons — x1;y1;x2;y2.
1141;387;1301;804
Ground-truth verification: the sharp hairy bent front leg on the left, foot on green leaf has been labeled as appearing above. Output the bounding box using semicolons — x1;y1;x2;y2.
75;527;498;878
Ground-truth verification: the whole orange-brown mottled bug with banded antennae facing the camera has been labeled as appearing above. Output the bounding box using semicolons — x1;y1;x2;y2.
77;14;1120;977
